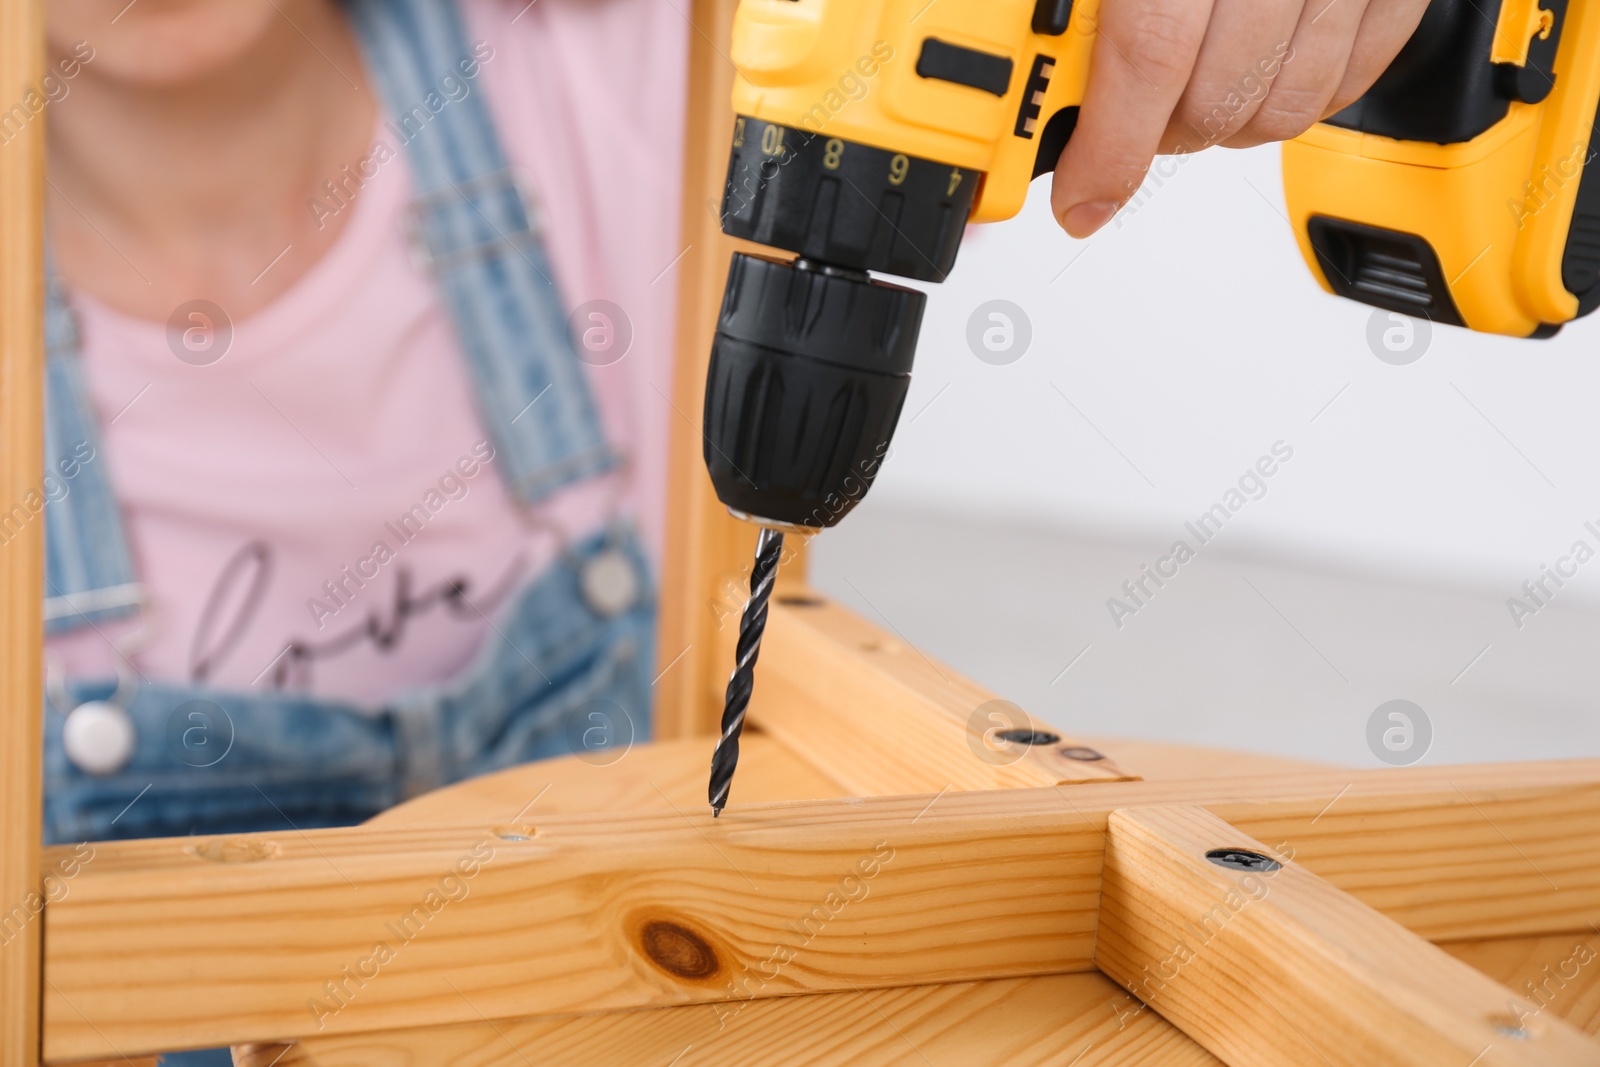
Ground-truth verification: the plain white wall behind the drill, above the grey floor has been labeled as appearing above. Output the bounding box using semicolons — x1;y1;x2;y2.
874;147;1600;601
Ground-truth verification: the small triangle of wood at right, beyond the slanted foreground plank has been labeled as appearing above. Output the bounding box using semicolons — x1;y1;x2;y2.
1438;928;1600;1037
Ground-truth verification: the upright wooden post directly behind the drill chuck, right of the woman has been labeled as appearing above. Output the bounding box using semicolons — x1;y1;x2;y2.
654;0;777;739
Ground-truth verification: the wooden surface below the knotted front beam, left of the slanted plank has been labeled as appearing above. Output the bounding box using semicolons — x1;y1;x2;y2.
237;974;1219;1067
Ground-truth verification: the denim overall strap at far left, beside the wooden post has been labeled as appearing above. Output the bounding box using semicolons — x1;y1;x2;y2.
41;271;142;633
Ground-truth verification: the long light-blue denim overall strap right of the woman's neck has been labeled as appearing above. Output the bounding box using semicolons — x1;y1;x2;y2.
346;0;616;504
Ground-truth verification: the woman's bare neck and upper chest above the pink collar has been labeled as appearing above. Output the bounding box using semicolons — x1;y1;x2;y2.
46;3;376;322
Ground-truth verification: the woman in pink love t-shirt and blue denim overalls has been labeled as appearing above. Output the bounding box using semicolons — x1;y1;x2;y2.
46;0;688;840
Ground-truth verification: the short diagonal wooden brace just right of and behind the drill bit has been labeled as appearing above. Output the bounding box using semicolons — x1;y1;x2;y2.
752;590;1133;797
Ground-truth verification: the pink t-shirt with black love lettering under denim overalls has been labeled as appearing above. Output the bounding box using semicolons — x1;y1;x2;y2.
50;0;688;705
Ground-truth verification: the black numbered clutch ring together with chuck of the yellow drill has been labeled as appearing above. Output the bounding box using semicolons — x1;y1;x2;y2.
704;117;981;530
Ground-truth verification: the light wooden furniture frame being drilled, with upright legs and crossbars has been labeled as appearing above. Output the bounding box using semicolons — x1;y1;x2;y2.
9;0;1600;1067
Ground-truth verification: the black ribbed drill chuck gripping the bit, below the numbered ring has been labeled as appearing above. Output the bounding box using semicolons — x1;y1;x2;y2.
704;253;926;530
